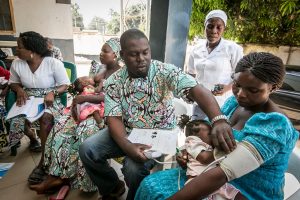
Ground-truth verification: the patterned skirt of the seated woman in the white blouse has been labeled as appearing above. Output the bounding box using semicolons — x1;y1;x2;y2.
9;88;64;147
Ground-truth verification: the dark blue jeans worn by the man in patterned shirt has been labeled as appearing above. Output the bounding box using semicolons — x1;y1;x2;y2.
79;128;155;200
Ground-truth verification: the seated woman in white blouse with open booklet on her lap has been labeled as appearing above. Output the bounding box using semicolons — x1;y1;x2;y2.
9;31;70;178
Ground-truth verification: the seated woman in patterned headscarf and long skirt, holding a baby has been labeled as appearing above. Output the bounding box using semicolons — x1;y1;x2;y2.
30;38;121;194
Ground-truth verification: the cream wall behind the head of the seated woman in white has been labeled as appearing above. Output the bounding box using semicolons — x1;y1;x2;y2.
1;0;74;62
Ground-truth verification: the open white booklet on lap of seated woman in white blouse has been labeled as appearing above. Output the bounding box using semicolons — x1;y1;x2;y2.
6;96;45;122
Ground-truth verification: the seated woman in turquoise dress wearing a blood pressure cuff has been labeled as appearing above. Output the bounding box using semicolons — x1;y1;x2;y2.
135;53;298;199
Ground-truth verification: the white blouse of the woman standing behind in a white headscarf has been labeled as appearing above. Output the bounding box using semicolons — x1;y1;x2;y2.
187;38;243;106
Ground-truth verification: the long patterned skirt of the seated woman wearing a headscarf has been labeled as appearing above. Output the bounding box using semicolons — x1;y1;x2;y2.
44;111;104;192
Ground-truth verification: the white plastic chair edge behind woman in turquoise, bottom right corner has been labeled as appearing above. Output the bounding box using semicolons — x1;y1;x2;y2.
283;173;300;200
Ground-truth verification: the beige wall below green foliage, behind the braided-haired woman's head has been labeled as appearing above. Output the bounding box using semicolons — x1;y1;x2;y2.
241;44;300;65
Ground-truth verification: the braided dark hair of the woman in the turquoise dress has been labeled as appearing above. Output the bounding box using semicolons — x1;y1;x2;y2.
235;52;285;89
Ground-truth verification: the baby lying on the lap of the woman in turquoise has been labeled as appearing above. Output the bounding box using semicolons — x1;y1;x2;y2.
185;120;245;199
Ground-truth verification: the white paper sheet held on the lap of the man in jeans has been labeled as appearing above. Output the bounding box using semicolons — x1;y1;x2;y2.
128;128;180;155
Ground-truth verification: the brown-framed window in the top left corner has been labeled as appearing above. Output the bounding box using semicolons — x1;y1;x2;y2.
0;0;15;34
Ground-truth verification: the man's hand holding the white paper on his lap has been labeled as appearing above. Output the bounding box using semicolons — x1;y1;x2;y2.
125;143;151;162
